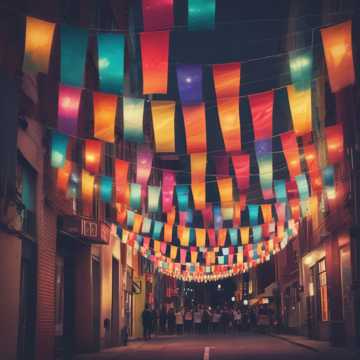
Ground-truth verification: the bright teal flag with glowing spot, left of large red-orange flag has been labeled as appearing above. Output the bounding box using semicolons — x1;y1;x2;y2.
97;33;125;95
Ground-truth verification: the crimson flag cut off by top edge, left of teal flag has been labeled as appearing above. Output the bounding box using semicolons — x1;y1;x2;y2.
142;0;174;31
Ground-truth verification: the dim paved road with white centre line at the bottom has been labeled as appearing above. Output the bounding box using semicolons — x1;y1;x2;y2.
78;334;358;360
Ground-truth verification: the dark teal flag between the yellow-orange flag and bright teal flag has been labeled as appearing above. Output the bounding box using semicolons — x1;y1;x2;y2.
60;24;88;87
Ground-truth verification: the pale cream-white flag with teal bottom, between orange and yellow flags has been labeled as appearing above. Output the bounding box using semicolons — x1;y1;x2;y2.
123;96;145;144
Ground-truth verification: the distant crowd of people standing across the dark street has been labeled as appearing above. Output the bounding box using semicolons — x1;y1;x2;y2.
143;305;268;340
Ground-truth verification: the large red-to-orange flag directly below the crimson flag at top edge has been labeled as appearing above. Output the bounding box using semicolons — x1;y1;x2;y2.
140;31;170;95
